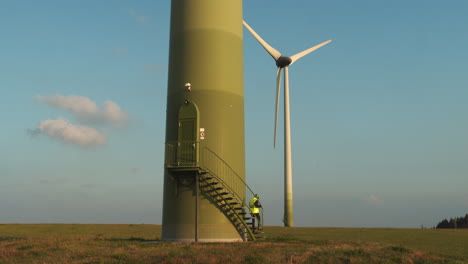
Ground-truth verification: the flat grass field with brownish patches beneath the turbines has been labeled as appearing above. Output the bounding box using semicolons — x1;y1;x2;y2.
0;224;468;264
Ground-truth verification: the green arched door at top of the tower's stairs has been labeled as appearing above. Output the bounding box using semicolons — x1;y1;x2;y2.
177;103;198;167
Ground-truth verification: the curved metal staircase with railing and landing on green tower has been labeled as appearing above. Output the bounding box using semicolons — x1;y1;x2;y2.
165;141;263;241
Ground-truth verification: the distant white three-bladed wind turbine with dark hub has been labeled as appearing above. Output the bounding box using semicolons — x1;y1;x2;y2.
242;21;331;227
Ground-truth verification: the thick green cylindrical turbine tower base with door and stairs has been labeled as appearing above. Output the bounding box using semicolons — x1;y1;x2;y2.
162;0;254;242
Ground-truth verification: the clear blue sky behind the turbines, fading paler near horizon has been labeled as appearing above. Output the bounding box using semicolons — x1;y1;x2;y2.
0;0;468;227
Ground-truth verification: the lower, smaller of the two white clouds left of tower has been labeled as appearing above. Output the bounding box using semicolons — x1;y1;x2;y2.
38;117;106;147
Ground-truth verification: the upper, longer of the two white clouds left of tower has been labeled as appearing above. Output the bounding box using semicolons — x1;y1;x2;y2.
37;94;129;128
